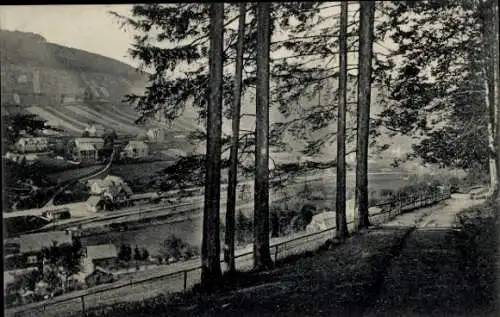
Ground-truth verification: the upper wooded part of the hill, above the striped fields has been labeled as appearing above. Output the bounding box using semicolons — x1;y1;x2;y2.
0;30;146;105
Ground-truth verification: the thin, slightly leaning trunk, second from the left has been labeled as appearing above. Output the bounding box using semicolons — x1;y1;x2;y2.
224;2;246;272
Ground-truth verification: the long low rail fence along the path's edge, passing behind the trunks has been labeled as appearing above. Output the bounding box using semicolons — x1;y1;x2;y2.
5;190;451;316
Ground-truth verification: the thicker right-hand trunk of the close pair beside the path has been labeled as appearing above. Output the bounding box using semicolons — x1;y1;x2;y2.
355;1;375;229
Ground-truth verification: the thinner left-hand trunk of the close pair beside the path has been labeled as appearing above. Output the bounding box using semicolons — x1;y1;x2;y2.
335;2;348;240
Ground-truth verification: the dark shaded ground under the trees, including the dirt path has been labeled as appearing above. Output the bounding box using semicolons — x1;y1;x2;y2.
76;191;496;316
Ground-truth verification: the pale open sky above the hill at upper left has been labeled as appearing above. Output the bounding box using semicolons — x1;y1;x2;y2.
0;5;137;66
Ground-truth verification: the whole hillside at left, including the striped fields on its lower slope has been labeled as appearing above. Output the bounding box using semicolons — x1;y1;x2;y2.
0;30;196;135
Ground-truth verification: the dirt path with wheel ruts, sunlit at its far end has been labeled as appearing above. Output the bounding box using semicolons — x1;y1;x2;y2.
363;195;496;317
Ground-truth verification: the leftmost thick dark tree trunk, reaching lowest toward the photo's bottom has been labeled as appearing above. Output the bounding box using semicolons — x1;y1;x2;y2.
201;3;224;287
